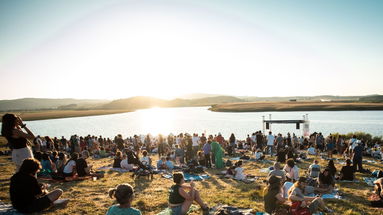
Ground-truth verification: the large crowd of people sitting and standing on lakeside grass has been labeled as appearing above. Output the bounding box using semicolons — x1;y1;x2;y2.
1;114;383;214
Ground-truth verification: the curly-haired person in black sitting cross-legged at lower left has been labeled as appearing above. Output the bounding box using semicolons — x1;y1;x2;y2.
9;158;68;213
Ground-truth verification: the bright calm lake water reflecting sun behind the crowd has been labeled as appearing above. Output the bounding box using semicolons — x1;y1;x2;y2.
3;107;383;139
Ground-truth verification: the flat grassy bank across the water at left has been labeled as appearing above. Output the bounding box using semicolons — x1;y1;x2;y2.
0;110;129;121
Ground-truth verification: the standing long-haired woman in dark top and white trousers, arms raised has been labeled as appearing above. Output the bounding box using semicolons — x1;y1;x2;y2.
1;113;35;172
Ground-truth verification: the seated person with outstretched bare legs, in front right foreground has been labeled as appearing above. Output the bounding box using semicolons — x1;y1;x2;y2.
288;177;333;214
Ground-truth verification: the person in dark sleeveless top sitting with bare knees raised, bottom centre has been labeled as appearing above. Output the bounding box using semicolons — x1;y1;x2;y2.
169;172;209;215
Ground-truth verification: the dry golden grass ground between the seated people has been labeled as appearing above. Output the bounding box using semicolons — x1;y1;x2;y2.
0;140;383;215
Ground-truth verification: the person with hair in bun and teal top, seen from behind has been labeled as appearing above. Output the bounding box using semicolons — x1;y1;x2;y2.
106;183;141;215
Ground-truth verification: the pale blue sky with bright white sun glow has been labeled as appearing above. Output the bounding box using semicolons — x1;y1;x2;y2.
0;0;383;99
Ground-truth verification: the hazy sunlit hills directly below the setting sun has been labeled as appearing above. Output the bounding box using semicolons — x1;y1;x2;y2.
99;96;244;110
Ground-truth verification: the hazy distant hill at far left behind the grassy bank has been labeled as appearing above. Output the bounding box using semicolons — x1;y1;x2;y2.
0;98;108;112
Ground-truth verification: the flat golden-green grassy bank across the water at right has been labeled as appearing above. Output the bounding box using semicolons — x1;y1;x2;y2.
210;102;383;112
